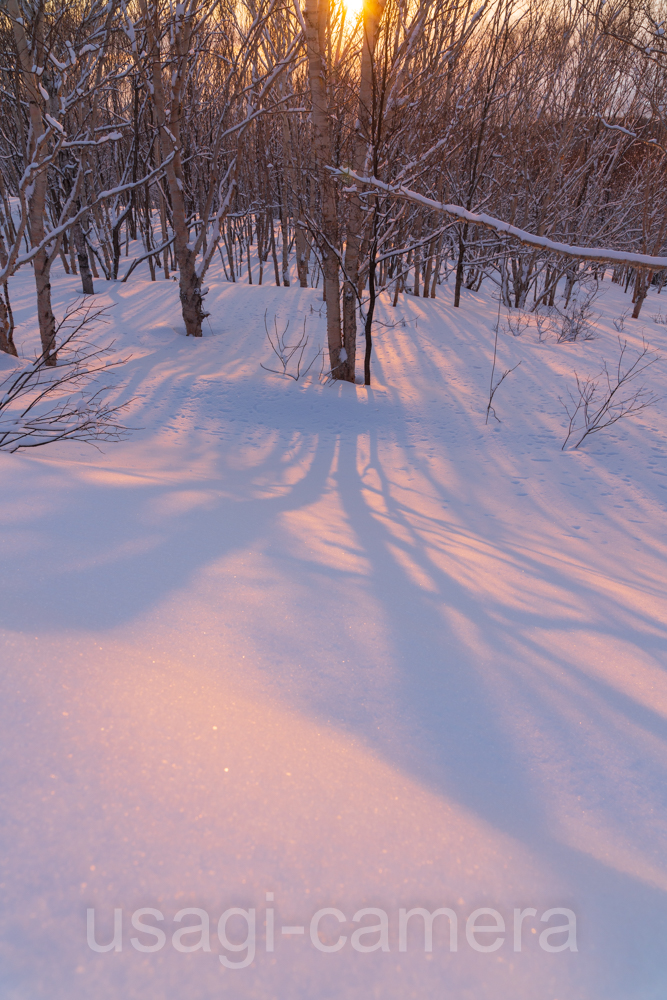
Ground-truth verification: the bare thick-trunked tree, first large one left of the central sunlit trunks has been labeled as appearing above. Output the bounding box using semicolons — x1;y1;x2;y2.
125;0;300;337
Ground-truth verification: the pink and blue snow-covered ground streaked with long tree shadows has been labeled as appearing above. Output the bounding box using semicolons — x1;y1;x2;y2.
0;260;667;1000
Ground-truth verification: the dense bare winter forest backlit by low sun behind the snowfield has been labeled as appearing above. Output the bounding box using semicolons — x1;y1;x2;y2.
0;0;667;383
